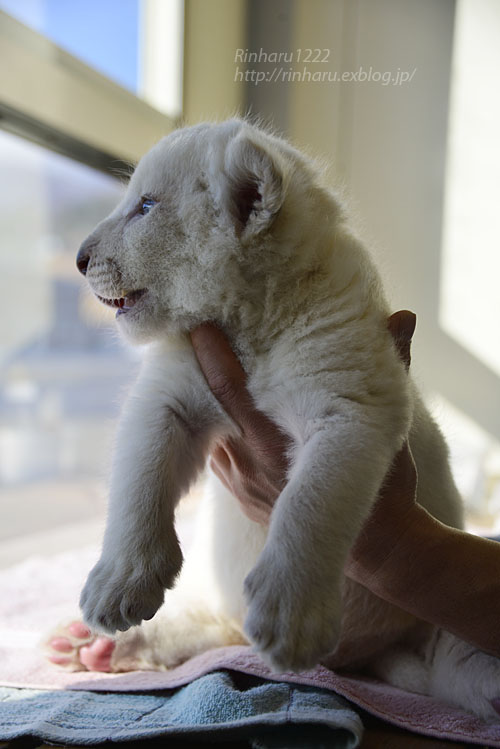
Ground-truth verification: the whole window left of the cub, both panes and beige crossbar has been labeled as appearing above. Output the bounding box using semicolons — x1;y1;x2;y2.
0;0;182;566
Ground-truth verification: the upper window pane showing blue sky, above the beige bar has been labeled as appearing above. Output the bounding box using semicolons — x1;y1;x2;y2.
0;0;183;117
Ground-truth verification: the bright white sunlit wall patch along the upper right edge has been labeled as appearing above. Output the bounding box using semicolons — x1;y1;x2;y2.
440;0;500;375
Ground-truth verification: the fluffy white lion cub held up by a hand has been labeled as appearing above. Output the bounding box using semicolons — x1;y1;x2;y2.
47;120;500;718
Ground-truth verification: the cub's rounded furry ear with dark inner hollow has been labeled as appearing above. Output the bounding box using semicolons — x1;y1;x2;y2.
223;134;285;237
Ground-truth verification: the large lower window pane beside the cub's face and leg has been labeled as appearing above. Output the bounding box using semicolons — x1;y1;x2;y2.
0;133;136;563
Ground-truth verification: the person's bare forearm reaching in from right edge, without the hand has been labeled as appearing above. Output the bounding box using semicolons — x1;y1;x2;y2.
346;505;500;656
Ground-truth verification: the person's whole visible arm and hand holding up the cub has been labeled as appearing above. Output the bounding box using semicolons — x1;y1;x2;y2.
191;312;500;655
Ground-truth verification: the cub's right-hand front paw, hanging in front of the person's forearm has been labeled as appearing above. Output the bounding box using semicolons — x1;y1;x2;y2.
244;552;341;672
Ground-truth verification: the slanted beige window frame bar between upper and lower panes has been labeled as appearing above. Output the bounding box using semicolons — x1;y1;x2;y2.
0;11;176;173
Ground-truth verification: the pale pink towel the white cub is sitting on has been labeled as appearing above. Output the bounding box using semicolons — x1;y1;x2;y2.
0;549;500;749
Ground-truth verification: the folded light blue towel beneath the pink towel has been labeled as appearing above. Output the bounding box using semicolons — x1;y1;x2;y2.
0;671;363;749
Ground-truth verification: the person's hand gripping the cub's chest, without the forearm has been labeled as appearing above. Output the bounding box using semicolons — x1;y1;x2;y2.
191;310;416;528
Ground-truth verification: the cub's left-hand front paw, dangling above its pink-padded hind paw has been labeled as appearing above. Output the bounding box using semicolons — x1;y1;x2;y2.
80;545;182;634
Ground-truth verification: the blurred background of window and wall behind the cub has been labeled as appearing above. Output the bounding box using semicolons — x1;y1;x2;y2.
0;0;500;566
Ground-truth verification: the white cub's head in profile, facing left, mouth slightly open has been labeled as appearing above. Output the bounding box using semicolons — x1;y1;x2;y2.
77;120;332;343
